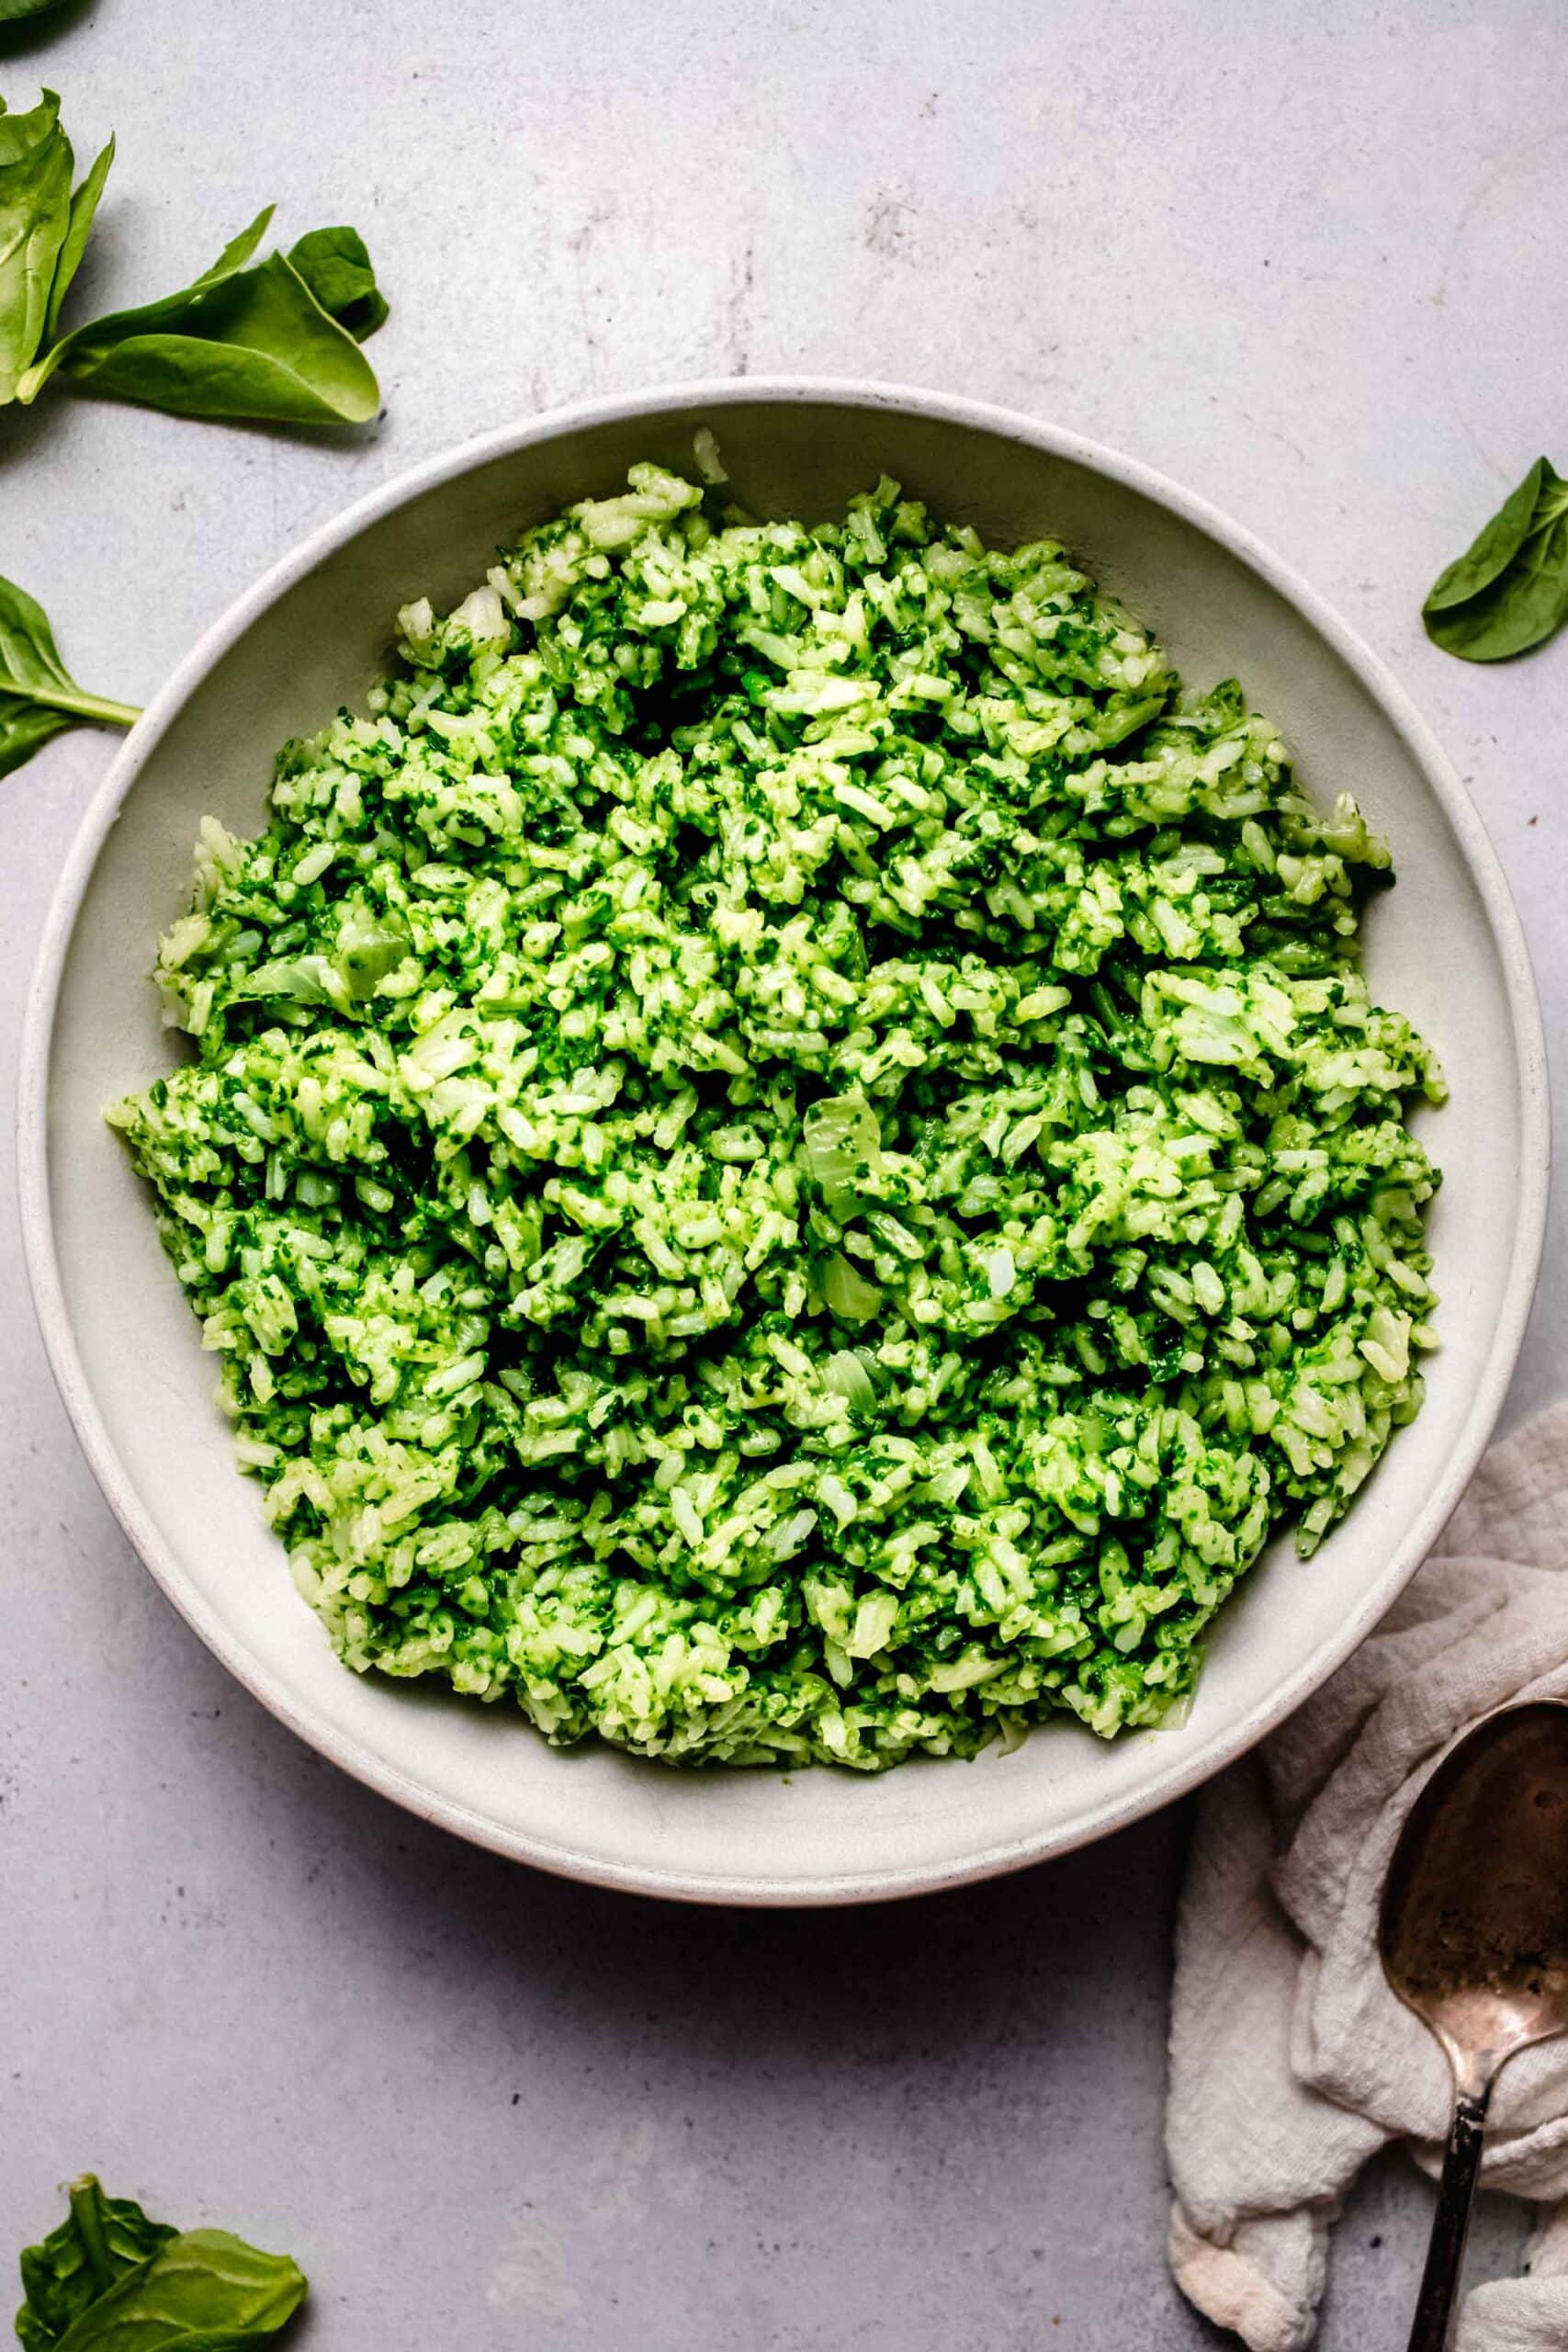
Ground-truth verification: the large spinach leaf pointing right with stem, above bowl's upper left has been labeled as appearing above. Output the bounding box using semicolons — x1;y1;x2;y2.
17;205;381;424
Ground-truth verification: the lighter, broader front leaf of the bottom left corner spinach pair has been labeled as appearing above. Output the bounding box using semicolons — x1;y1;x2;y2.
54;2230;306;2352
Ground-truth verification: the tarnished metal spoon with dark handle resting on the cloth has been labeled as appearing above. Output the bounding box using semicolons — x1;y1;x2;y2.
1380;1698;1568;2352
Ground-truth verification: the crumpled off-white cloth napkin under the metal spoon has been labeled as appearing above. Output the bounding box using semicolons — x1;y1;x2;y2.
1166;1404;1568;2352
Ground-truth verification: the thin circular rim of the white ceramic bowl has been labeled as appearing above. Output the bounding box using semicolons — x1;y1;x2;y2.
17;377;1551;1907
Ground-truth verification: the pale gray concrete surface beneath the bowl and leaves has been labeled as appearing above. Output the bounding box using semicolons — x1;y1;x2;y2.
0;0;1568;2352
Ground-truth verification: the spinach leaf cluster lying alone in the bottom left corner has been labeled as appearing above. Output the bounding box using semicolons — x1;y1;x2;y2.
17;2173;306;2352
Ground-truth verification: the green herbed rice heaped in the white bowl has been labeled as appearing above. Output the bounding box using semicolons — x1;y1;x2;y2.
110;452;1443;1769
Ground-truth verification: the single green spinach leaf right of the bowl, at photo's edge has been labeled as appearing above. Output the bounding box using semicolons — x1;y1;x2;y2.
1422;457;1568;661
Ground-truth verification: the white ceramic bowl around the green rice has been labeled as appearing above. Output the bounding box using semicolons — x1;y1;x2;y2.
21;381;1547;1903
